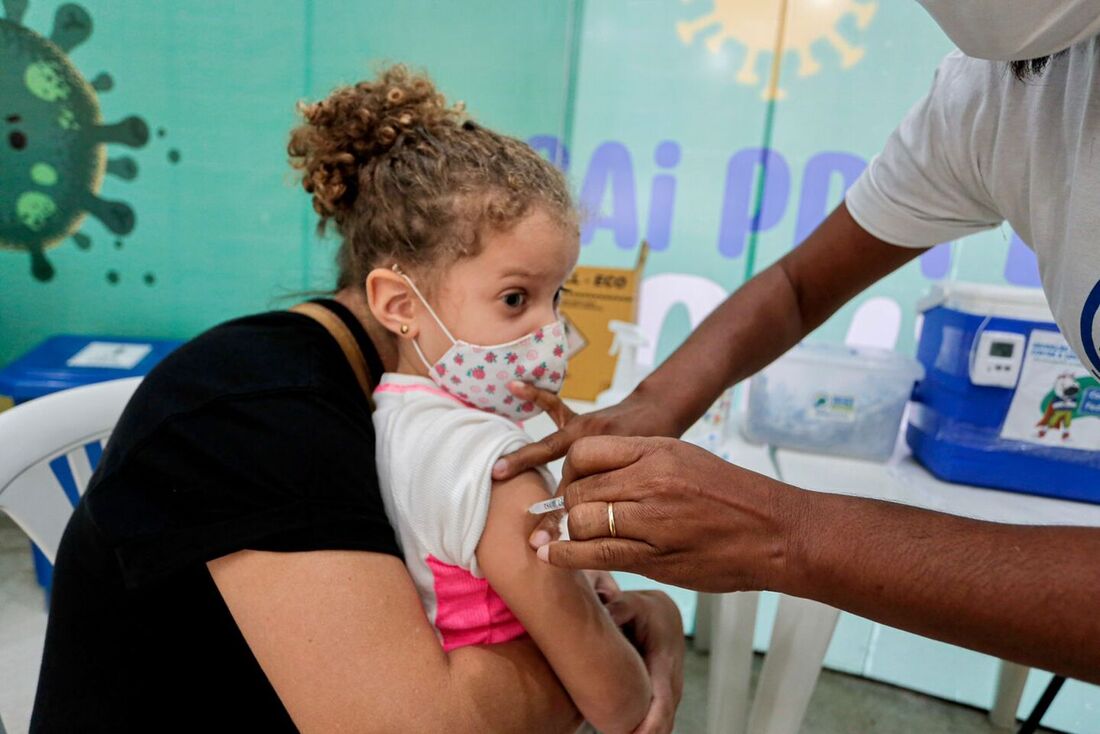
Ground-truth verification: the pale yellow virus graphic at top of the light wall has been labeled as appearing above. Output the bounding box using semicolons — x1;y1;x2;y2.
677;0;878;99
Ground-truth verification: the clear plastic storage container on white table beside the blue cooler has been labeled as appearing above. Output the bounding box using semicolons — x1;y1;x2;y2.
743;343;924;461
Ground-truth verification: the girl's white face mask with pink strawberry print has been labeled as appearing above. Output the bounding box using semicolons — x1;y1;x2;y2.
399;268;568;421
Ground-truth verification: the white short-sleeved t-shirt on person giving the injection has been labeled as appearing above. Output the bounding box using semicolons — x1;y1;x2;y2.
846;39;1100;377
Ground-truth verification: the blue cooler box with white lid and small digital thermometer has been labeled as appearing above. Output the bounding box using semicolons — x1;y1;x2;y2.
906;283;1100;503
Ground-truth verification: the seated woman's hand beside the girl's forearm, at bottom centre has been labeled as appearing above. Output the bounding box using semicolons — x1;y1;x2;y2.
607;591;684;734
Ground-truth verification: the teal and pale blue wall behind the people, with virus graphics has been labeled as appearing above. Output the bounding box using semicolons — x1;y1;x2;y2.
0;0;1100;731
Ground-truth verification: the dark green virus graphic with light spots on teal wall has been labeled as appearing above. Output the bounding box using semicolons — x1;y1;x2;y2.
0;0;149;281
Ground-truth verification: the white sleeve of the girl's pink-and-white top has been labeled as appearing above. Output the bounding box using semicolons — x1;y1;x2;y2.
395;409;551;578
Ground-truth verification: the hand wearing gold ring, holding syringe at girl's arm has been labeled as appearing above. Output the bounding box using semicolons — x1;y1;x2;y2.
538;436;802;592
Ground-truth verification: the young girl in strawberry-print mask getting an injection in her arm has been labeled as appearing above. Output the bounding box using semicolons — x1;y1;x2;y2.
292;67;668;732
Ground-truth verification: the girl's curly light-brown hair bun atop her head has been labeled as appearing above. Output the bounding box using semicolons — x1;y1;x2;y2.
287;65;463;228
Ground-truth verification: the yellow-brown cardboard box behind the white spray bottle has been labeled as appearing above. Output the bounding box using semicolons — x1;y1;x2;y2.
561;242;649;401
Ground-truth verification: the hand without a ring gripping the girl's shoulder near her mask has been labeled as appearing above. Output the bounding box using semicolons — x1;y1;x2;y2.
493;382;683;484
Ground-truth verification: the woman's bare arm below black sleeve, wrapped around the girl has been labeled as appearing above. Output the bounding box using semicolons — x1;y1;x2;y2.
208;550;581;734
